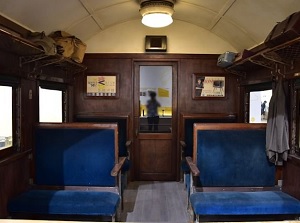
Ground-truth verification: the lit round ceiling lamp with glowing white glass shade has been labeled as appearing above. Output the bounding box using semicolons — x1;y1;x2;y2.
140;0;174;28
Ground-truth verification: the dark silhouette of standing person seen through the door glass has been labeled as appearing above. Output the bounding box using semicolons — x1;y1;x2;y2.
146;91;160;131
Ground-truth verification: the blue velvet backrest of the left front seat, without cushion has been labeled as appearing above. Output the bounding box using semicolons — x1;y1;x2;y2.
35;124;118;186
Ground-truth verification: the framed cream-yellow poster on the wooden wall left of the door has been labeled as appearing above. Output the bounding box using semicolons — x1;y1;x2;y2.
86;73;119;98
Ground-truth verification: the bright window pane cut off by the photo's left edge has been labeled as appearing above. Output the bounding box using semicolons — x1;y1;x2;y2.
0;85;13;150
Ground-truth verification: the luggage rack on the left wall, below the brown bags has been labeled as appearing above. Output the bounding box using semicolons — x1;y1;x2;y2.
0;28;87;74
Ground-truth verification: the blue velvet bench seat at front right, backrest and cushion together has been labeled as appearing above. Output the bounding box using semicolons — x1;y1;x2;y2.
190;123;300;220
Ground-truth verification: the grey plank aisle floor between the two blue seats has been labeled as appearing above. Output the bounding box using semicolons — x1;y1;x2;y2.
119;182;191;223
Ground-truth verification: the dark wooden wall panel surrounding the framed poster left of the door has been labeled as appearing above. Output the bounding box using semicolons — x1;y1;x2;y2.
74;57;133;114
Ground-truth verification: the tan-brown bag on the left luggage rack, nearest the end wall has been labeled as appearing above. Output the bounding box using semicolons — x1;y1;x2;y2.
49;31;86;63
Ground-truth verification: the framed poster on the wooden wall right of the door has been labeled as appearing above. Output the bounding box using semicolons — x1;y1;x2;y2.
192;73;226;99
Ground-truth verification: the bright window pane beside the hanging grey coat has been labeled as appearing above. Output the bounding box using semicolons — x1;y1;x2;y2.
249;90;272;123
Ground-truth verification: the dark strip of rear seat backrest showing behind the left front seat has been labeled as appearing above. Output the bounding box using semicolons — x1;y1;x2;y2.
76;117;128;156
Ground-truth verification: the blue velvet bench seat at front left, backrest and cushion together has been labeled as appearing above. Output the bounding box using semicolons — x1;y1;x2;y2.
8;123;121;219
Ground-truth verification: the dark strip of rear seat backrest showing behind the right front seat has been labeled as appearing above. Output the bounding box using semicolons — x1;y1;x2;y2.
184;118;236;156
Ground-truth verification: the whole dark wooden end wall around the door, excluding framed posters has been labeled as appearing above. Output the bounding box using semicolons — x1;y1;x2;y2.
74;54;238;117
